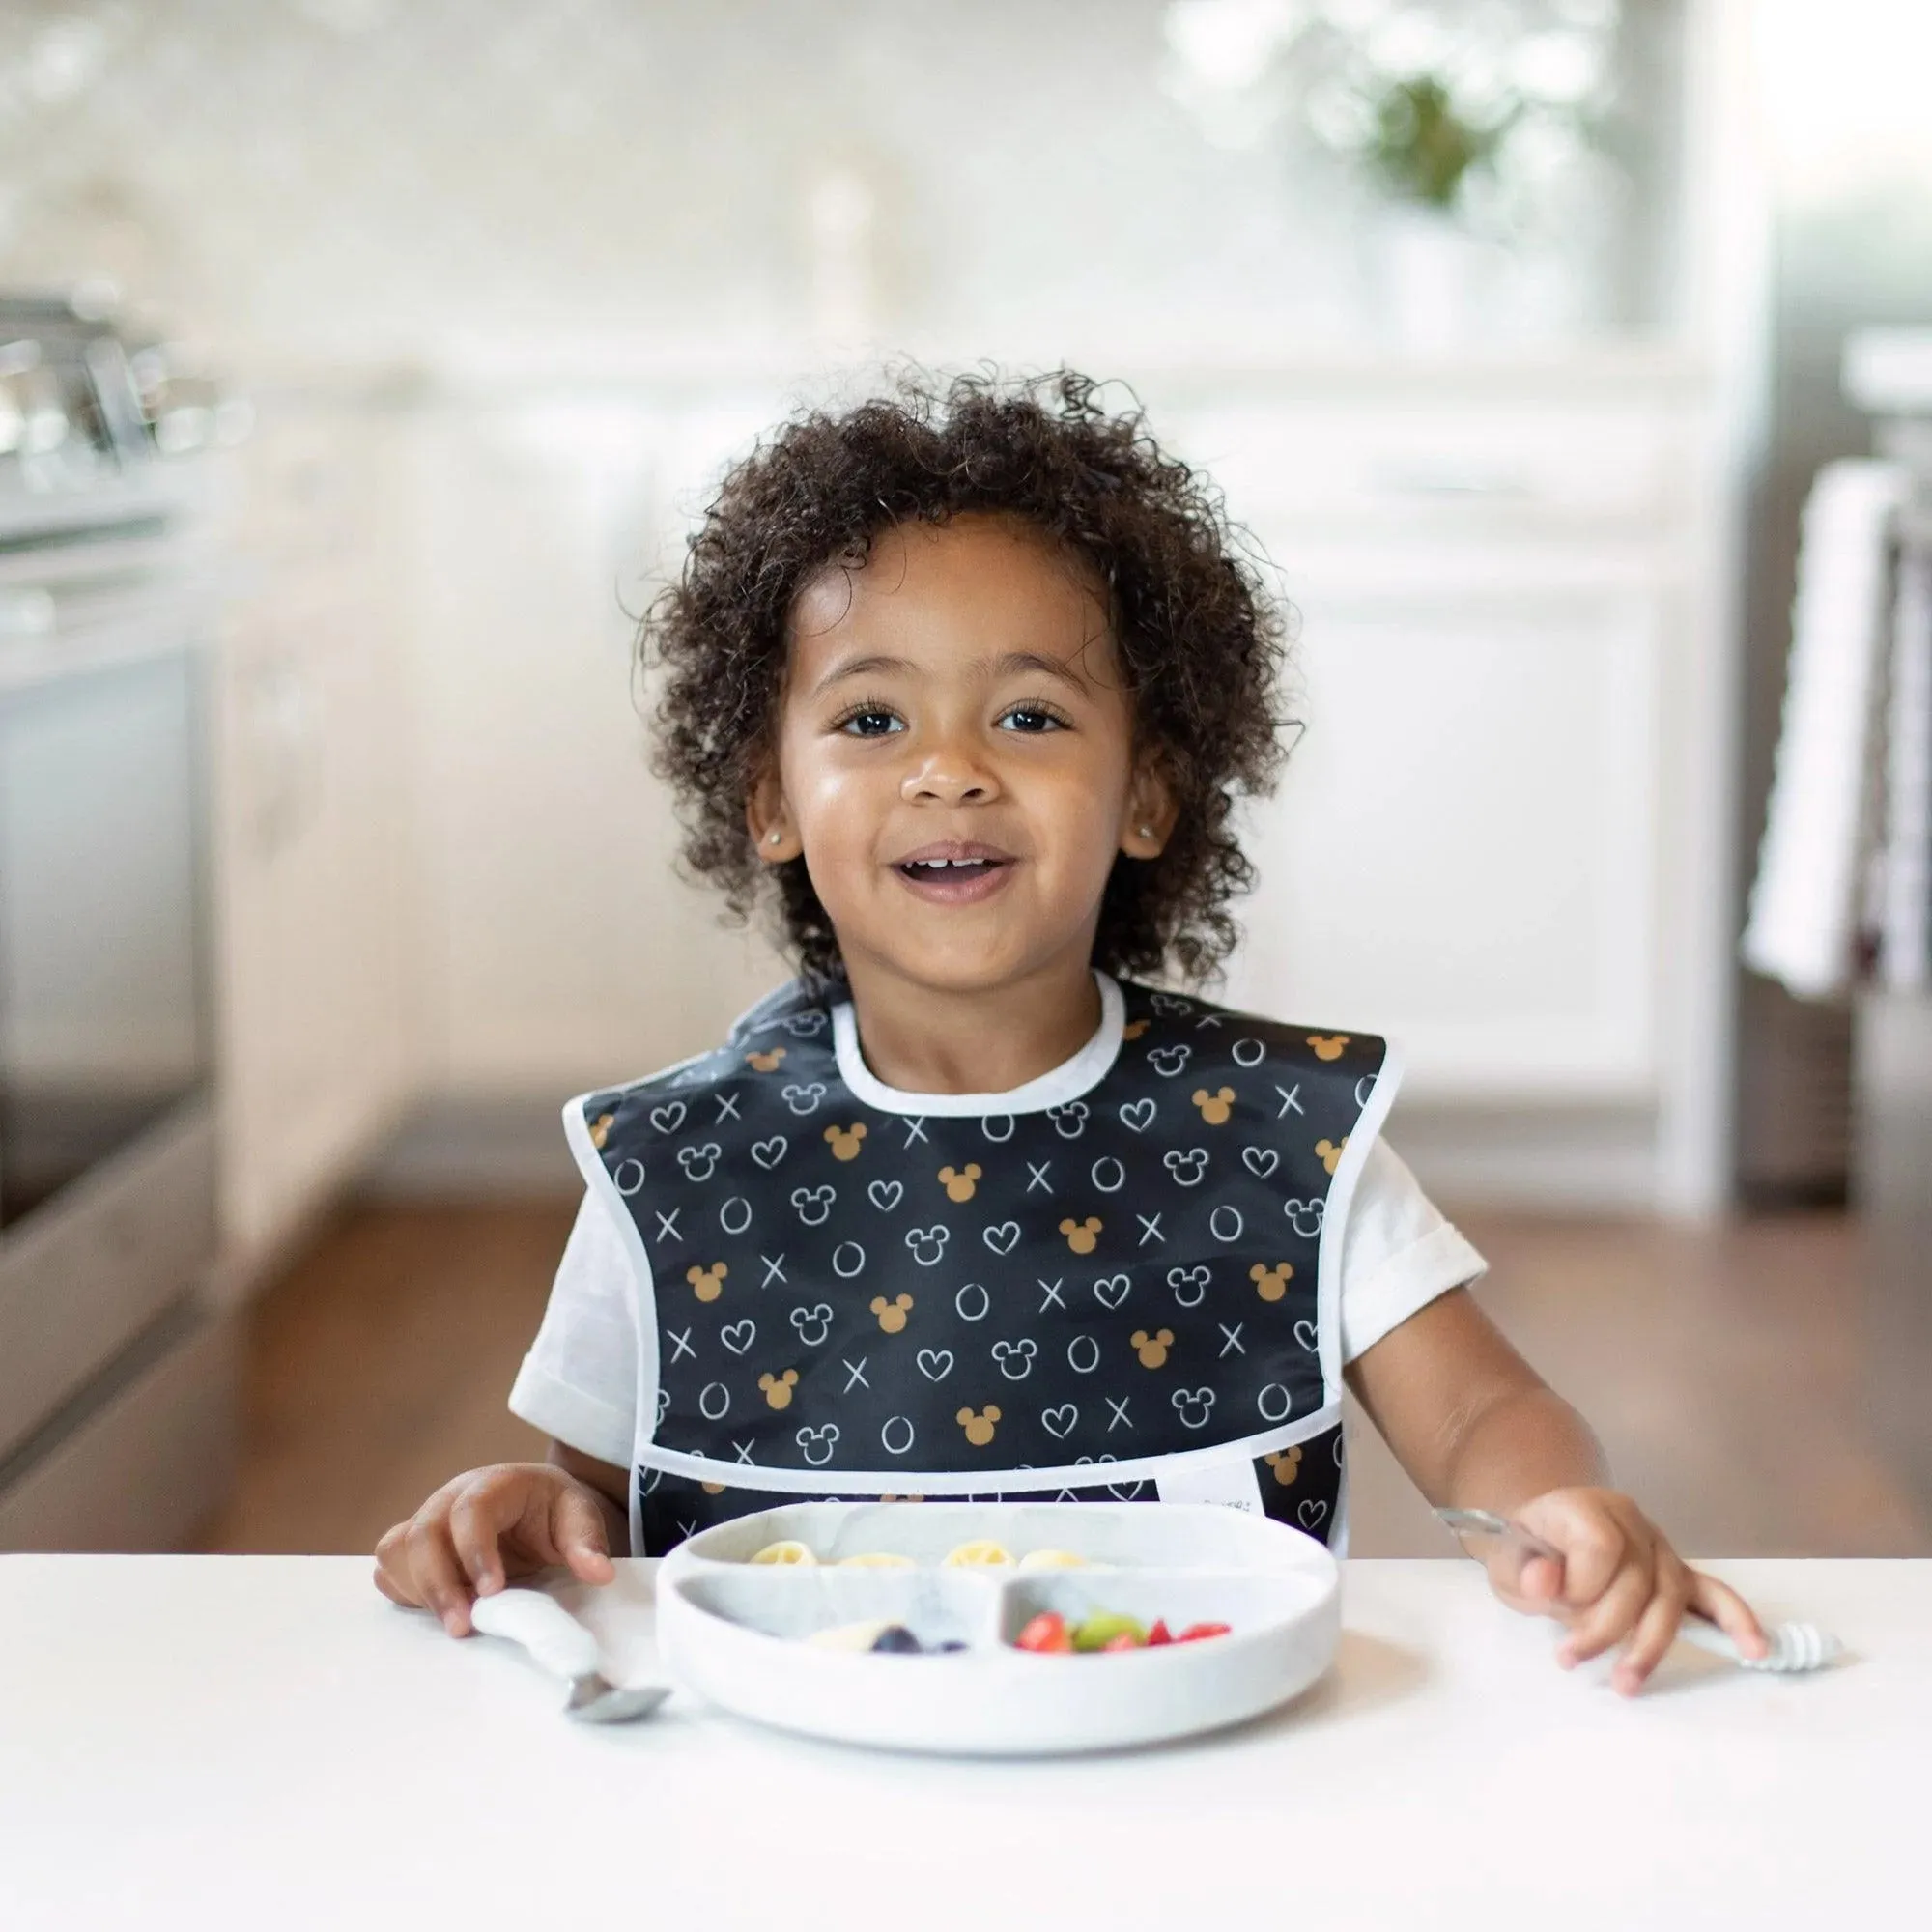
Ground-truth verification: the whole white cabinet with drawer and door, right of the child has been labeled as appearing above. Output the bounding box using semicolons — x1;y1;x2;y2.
1155;363;1725;1206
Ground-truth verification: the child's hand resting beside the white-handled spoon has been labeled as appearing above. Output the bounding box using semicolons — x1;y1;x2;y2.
375;1463;616;1636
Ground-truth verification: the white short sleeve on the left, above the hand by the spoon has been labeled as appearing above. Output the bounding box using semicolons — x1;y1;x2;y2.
510;1194;638;1468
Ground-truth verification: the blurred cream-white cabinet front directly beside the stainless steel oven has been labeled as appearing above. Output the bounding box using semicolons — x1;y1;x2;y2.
214;390;415;1271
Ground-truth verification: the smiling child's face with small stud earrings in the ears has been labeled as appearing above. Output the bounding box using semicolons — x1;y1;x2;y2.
748;516;1173;991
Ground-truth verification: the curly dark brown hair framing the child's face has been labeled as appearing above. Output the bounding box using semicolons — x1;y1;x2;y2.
639;369;1287;981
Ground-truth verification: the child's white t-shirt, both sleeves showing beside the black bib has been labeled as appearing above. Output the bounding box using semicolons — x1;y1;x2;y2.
510;1140;1488;1468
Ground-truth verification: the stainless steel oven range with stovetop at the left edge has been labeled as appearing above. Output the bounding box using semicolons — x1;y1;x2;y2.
0;298;234;1549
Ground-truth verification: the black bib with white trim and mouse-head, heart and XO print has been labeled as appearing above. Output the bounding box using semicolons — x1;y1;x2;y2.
566;980;1393;1542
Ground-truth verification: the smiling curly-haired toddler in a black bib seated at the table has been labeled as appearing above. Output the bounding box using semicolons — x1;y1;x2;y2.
377;373;1764;1690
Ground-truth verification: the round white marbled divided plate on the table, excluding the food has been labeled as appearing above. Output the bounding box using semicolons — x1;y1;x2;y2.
657;1503;1341;1754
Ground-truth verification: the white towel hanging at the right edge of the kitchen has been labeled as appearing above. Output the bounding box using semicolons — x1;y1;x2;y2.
1743;462;1907;999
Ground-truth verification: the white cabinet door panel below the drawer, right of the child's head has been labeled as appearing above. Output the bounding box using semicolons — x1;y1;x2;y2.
1233;572;1658;1099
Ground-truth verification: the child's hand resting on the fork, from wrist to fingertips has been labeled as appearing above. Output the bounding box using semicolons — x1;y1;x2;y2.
1478;1490;1770;1696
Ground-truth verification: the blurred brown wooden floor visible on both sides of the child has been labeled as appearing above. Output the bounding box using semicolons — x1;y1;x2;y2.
203;1204;1932;1555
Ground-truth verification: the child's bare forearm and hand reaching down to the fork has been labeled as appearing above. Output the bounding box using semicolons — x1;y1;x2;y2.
1349;1289;1766;1692
